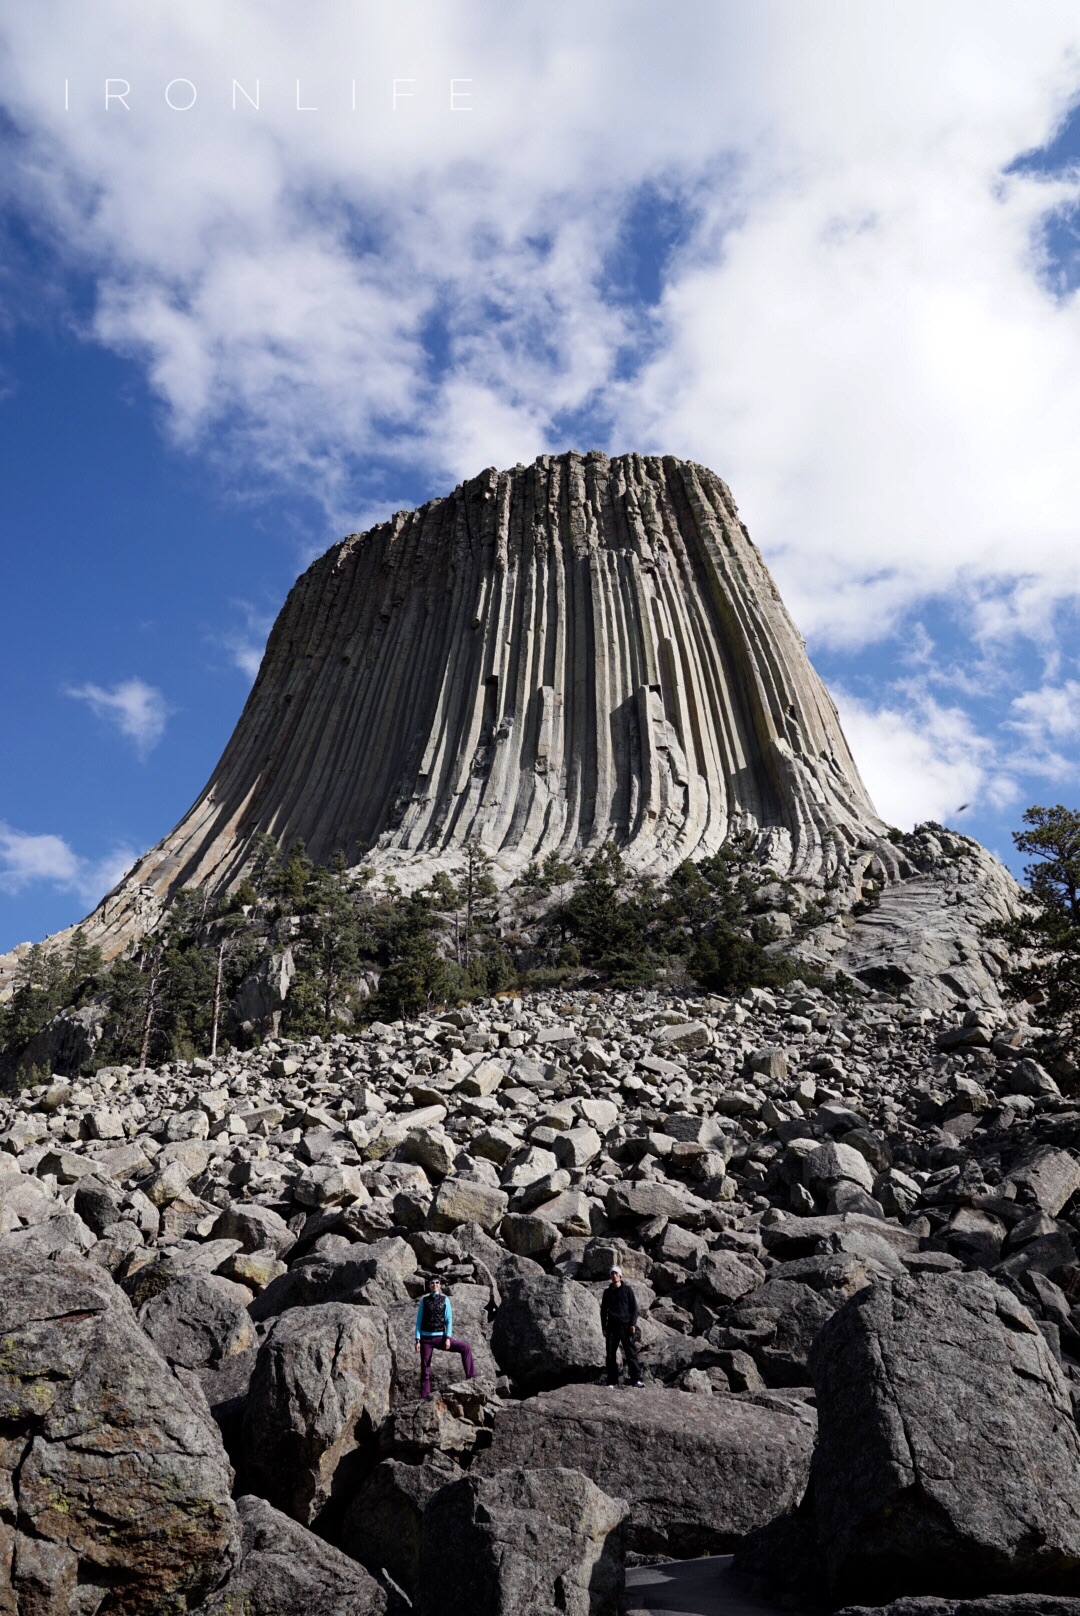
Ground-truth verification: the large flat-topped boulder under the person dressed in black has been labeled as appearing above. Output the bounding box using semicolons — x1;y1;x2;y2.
474;1385;813;1555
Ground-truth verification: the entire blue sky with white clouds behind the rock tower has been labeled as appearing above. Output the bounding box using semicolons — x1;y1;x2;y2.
0;0;1080;950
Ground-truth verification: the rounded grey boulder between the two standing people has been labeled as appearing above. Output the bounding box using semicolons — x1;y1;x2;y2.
491;1273;605;1391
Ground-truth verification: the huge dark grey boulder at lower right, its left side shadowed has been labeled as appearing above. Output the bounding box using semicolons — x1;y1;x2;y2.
812;1273;1080;1603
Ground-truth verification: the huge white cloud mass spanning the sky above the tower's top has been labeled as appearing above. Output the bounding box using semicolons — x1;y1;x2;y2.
0;0;1080;645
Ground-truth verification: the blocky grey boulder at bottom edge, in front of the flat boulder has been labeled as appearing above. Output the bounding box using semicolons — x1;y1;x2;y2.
416;1467;627;1616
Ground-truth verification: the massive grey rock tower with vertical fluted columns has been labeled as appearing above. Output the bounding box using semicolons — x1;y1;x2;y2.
90;452;884;931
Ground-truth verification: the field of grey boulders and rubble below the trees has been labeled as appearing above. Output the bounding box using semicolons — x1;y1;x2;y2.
0;984;1080;1616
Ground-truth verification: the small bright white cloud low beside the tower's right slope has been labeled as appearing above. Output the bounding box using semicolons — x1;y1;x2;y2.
834;690;1017;831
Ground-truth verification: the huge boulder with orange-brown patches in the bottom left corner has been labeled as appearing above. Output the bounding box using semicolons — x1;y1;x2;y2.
0;1246;238;1616
